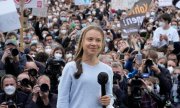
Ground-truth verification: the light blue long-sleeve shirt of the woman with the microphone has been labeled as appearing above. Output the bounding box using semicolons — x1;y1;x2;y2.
57;61;113;108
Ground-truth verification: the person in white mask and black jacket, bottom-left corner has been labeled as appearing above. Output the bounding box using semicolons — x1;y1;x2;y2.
0;74;28;108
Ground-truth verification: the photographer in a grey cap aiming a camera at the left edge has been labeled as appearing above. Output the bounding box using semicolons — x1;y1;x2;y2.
0;39;26;76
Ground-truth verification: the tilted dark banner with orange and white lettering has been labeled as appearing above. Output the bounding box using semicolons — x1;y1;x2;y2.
120;0;151;36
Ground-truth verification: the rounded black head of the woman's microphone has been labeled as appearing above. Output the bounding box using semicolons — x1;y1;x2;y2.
98;72;108;85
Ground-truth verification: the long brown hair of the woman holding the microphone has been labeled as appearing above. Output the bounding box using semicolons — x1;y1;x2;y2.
74;25;105;79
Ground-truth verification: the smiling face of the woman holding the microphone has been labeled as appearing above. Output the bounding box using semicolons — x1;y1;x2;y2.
82;30;103;56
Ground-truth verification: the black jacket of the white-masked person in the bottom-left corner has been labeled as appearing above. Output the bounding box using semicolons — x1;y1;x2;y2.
0;91;28;108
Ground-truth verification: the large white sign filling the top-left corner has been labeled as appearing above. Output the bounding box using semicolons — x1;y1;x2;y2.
0;0;21;32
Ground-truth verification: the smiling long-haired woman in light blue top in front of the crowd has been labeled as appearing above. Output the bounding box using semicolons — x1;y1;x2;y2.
57;26;113;108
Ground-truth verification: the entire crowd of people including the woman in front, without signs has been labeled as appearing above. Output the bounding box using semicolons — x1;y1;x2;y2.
0;0;180;108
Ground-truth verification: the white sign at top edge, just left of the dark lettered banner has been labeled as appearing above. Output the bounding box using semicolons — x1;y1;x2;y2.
111;0;139;10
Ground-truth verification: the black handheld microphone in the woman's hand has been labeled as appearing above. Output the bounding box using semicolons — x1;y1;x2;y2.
98;72;108;108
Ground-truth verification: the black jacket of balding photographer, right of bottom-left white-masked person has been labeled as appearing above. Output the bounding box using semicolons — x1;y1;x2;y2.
25;93;57;108
